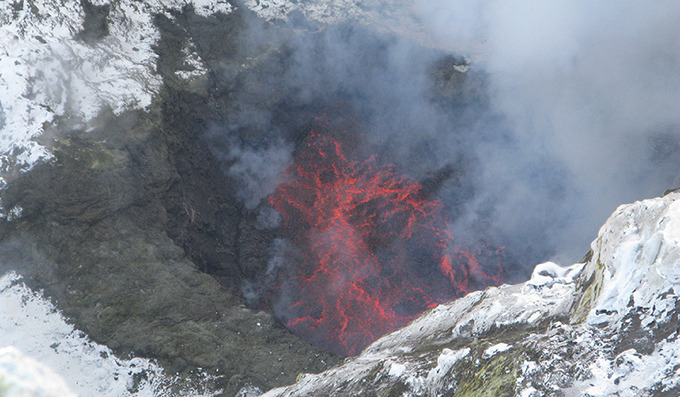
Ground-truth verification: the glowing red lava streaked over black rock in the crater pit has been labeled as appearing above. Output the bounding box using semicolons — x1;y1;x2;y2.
270;133;499;355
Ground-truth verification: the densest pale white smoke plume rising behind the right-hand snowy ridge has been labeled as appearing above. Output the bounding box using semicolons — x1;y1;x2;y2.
415;0;680;260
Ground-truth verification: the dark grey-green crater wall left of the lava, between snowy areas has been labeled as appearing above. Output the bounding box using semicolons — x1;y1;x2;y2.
0;6;337;395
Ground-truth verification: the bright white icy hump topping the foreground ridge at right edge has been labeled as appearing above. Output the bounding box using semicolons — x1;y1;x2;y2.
588;193;680;324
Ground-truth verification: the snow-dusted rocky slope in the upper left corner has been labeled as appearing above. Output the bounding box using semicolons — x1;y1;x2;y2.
0;0;232;177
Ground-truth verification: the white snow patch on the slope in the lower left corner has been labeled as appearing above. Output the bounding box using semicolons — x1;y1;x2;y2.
0;272;215;397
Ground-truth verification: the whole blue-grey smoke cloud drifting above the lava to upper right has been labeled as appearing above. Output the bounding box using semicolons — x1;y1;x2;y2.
225;0;680;276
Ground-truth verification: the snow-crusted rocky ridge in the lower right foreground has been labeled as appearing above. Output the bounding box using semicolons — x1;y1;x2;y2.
264;193;680;397
